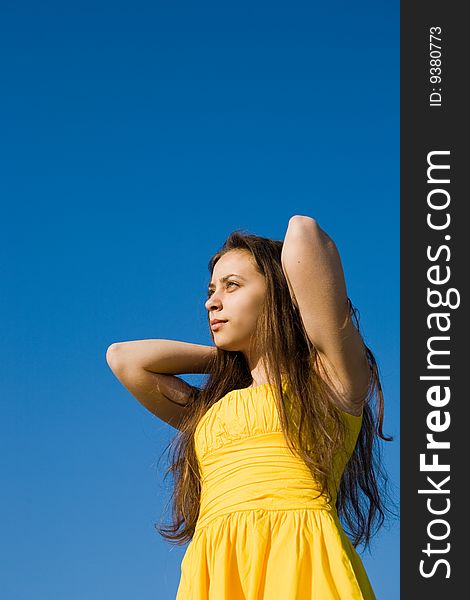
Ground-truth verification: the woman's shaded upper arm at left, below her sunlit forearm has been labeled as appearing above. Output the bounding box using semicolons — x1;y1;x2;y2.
108;361;199;429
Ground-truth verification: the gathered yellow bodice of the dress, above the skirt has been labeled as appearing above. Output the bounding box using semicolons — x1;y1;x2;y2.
195;381;361;528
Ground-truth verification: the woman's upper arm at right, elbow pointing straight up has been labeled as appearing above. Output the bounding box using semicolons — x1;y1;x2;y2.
281;215;370;414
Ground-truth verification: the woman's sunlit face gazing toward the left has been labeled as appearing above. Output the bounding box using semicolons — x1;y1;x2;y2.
205;250;266;352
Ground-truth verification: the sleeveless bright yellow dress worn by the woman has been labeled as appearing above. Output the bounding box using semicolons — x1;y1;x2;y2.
176;379;376;600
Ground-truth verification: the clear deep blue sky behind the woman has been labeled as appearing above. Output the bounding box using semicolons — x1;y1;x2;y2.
0;0;399;600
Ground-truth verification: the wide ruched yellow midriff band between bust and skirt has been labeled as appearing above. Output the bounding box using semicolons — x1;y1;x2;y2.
197;431;336;529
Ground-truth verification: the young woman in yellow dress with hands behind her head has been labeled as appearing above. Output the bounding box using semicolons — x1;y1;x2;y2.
107;215;392;600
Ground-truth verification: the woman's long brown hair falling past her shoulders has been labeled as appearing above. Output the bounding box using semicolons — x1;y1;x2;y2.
155;230;393;546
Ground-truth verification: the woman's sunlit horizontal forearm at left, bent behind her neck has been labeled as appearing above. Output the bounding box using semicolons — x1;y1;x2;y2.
106;339;217;375
